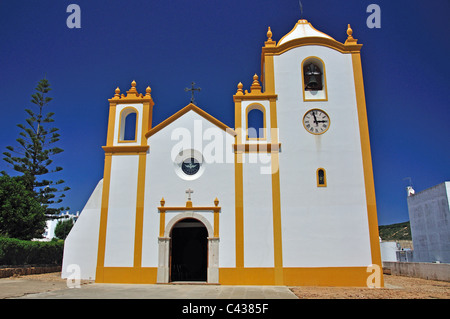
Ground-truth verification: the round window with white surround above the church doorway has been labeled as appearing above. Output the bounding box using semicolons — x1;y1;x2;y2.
174;149;205;180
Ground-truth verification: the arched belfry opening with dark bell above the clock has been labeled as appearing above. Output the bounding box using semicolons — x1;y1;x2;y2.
302;57;327;101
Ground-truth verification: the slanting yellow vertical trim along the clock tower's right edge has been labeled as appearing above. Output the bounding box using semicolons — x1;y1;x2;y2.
352;53;384;287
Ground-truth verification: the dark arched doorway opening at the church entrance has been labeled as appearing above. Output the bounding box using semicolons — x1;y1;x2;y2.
170;218;208;281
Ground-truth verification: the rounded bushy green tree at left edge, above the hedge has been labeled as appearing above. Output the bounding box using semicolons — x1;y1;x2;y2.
0;176;46;239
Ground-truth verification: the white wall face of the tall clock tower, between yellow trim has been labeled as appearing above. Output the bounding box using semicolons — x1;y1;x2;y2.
274;46;371;267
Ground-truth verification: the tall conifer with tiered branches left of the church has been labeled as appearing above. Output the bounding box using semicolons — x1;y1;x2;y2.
3;78;70;218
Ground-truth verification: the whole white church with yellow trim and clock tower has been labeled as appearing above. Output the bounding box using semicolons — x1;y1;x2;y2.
62;19;382;286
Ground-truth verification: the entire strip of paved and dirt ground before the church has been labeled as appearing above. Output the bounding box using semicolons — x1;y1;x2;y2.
0;273;450;300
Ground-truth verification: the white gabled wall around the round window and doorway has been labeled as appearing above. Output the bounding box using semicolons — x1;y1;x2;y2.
142;111;235;267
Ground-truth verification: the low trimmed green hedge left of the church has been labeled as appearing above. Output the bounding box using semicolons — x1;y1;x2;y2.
0;237;64;265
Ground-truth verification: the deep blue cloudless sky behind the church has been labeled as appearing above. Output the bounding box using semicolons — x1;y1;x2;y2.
0;0;450;225
